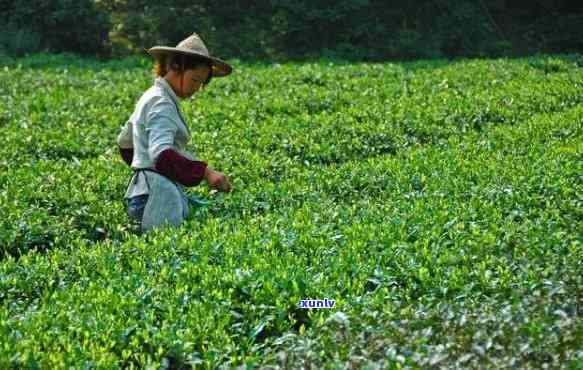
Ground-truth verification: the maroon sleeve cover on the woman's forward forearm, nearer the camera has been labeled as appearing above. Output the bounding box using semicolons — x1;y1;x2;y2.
155;149;207;186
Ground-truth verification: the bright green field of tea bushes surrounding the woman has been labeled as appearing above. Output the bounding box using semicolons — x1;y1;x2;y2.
0;54;583;369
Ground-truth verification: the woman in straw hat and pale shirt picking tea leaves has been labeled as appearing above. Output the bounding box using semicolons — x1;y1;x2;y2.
117;34;232;231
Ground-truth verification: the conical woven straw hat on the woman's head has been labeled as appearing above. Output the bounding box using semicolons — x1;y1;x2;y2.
146;33;233;77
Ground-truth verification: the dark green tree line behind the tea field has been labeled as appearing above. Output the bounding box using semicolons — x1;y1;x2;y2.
0;0;583;60
